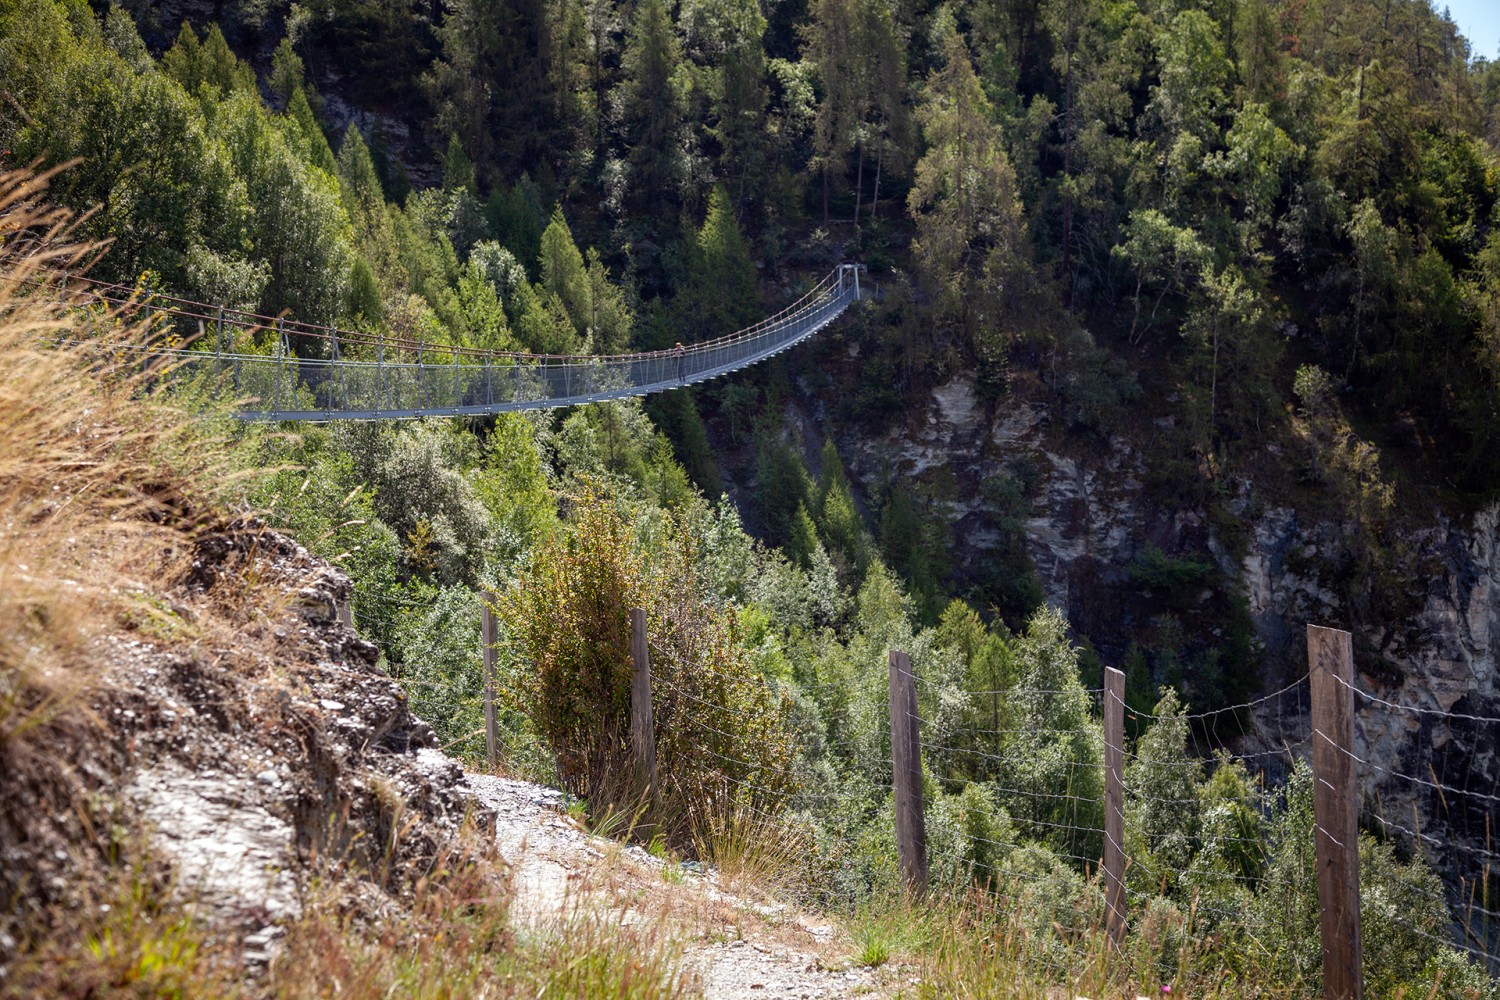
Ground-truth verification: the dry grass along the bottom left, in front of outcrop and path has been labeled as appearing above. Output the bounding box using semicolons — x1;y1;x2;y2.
0;828;695;1000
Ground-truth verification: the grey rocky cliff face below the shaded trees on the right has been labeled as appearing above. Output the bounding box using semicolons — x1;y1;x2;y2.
807;378;1500;869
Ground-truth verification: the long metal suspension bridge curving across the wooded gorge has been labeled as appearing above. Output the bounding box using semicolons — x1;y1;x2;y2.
55;264;869;421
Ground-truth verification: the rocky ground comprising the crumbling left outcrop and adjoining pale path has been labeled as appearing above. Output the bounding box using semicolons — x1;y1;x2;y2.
0;523;912;997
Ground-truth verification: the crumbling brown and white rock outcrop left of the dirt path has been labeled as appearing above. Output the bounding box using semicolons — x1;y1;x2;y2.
0;523;494;967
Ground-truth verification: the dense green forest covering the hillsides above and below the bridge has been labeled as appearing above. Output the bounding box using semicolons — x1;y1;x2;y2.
0;0;1500;997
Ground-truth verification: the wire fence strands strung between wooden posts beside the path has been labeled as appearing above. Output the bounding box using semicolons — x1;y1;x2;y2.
345;581;1500;996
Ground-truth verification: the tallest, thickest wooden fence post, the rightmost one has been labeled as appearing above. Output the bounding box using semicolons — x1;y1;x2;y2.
1308;625;1365;1000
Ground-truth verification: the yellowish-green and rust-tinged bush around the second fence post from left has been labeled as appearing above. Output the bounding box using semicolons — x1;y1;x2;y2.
498;490;795;841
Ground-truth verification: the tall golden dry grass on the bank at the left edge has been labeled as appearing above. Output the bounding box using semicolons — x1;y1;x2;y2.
0;172;235;749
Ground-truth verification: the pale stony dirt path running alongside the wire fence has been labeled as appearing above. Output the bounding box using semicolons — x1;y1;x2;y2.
468;775;902;1000
